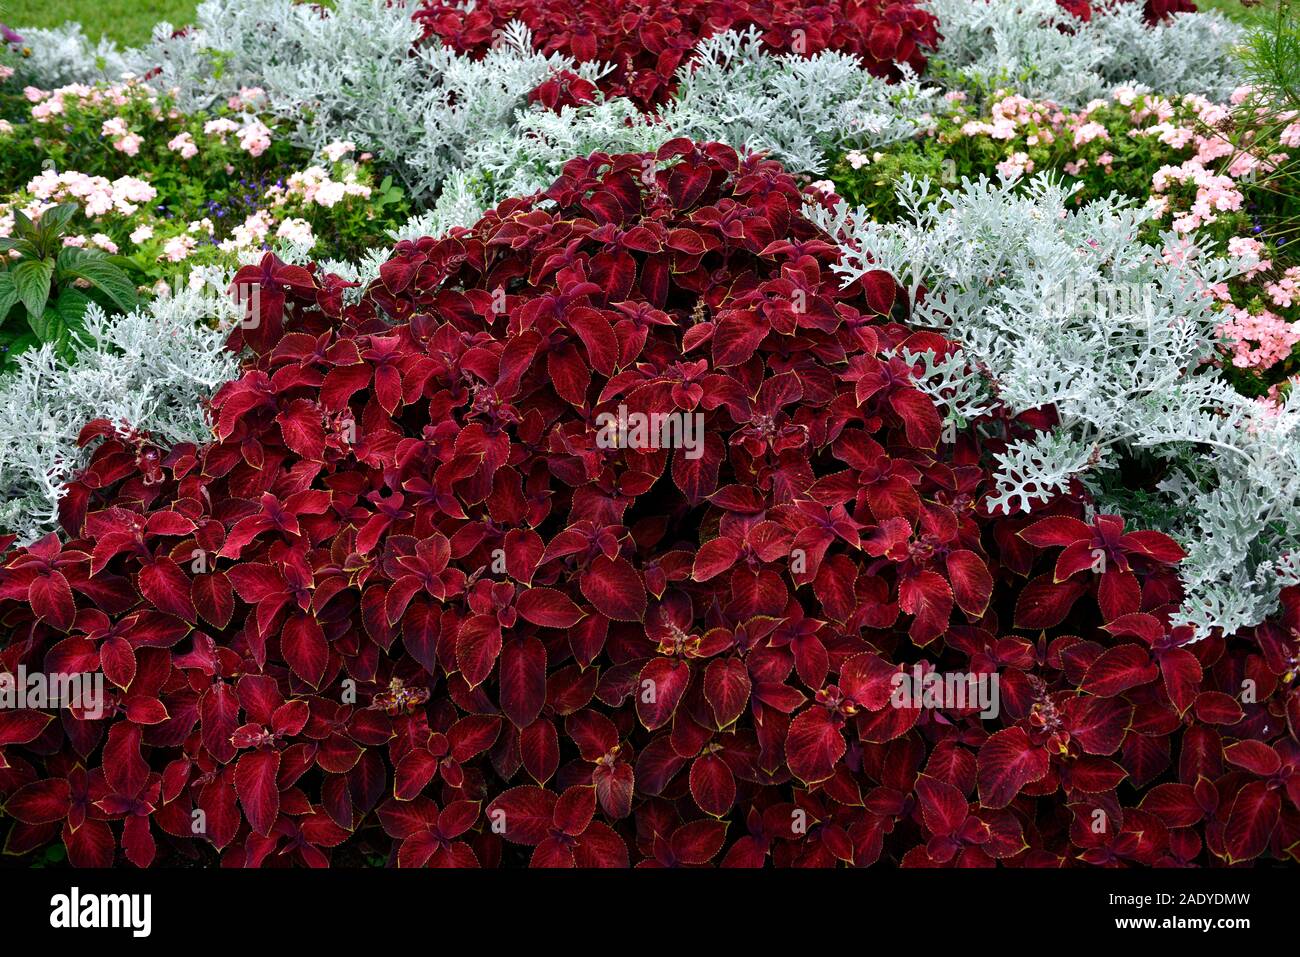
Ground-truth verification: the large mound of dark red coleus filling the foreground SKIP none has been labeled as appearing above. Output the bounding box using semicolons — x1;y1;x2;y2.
0;140;1300;867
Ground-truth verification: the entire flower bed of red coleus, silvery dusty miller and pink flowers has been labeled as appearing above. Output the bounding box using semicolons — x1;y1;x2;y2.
0;0;1300;867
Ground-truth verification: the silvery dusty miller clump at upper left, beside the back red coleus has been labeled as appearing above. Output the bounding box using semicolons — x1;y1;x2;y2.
118;0;605;200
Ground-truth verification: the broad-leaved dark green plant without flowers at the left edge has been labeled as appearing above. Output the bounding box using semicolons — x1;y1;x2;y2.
0;203;137;369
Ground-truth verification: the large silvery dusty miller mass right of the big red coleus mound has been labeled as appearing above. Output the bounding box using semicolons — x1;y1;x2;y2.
814;177;1300;633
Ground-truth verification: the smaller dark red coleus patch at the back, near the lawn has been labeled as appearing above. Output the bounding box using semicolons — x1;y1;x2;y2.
415;0;939;105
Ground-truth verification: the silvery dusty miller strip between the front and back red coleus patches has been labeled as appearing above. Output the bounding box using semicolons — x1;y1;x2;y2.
395;30;939;238
